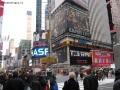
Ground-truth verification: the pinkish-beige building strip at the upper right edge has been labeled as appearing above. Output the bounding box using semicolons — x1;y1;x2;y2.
110;0;120;45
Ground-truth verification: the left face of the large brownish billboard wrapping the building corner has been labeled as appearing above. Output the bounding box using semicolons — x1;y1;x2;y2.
51;6;67;38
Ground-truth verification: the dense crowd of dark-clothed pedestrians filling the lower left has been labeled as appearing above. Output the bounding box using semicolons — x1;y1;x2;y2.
0;70;56;90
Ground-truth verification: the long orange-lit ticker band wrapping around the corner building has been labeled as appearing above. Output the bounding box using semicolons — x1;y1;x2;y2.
52;41;112;51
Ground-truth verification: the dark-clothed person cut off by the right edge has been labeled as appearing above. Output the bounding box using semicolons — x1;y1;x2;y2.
113;69;120;90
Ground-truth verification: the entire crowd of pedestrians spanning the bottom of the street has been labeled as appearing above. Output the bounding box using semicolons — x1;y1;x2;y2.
0;69;120;90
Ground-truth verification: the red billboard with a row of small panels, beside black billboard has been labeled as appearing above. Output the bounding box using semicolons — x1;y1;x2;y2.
92;50;113;67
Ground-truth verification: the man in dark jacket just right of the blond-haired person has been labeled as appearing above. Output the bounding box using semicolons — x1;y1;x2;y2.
83;70;98;90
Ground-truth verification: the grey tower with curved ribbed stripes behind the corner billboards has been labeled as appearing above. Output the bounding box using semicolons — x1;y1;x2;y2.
89;0;111;45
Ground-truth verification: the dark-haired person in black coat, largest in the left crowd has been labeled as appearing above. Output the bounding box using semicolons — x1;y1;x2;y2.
8;71;24;90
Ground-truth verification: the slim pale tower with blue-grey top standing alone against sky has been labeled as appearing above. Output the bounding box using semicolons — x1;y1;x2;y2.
26;11;32;40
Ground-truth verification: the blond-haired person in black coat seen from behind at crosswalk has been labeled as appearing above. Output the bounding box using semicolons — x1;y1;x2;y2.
63;72;80;90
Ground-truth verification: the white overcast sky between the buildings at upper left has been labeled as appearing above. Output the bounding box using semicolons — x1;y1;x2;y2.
2;0;36;54
